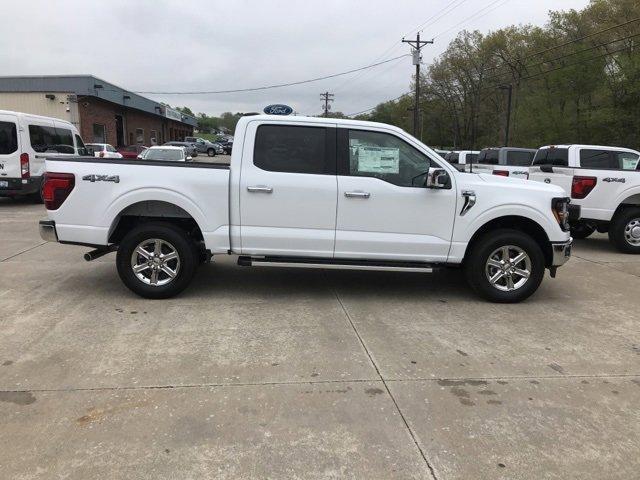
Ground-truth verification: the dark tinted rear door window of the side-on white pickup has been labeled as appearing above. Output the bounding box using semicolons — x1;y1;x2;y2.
253;125;331;174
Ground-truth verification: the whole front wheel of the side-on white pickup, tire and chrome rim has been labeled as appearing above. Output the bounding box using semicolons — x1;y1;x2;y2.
464;229;545;303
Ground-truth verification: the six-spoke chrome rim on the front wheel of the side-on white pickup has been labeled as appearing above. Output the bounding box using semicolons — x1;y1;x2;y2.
485;245;531;292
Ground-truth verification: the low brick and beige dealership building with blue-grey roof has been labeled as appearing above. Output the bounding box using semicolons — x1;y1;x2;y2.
0;75;198;147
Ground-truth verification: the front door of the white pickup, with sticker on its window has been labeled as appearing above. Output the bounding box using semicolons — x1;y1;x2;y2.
335;129;457;262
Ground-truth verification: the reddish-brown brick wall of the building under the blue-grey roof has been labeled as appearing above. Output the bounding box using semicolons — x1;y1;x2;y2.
78;97;193;146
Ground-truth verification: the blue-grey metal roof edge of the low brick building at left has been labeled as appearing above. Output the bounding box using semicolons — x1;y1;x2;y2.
0;75;198;127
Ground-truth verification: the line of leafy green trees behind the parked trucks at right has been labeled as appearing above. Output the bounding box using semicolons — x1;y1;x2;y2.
356;0;640;149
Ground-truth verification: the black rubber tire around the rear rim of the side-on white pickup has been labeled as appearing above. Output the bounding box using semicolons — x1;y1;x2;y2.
116;222;199;299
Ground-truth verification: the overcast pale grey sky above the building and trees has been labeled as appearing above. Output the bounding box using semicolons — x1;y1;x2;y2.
0;0;589;115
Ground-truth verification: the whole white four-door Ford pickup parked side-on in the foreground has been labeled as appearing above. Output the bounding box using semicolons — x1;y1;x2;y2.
40;116;571;302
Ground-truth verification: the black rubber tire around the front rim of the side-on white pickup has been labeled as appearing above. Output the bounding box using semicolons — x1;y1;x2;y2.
464;229;545;303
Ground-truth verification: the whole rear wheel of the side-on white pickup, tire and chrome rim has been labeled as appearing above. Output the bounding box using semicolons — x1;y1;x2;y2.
116;222;199;299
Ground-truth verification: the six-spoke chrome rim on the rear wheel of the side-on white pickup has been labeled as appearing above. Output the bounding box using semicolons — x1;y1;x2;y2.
131;238;180;287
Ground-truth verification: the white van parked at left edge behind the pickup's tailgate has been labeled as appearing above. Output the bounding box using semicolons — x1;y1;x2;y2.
0;110;87;199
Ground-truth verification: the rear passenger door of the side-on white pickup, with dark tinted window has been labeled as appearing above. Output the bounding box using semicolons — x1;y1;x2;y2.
239;121;337;258
